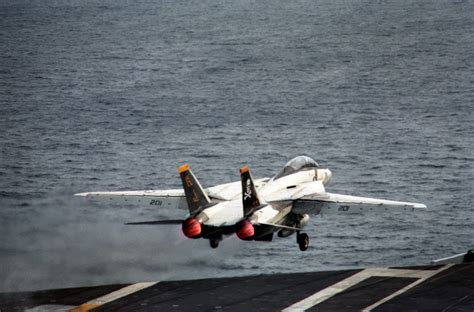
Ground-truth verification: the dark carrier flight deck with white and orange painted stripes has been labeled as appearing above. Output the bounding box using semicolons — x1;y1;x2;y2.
0;263;474;312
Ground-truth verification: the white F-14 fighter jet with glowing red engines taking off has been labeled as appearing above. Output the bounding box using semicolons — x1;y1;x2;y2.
75;156;426;251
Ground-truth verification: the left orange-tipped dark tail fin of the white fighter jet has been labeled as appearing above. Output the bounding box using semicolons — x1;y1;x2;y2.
178;164;211;215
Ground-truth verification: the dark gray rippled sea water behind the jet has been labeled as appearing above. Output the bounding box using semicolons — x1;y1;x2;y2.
0;0;474;291
